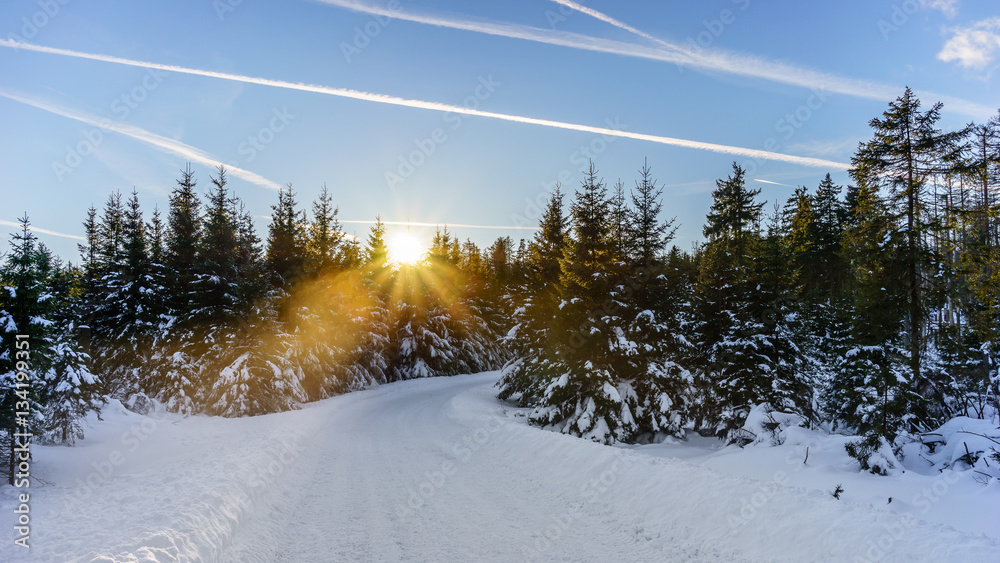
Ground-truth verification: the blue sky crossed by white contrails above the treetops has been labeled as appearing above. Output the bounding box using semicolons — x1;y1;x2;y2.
0;0;1000;262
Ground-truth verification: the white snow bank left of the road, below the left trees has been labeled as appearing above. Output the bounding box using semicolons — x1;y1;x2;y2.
0;401;336;563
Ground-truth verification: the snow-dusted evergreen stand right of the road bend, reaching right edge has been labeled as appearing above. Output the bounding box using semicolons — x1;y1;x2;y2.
500;89;1000;472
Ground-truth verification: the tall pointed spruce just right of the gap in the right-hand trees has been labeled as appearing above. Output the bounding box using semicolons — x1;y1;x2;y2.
697;164;811;441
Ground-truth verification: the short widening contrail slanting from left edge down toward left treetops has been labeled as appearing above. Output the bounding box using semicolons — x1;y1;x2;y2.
0;90;281;192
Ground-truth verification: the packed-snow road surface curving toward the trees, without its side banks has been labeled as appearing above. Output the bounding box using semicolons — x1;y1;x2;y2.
223;375;731;561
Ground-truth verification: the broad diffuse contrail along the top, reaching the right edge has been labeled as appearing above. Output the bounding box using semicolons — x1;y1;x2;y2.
315;0;996;119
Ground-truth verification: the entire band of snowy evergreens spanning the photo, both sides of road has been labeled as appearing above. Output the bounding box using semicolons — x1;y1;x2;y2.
0;89;1000;480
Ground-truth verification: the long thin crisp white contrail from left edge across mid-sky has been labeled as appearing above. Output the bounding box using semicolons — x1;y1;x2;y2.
0;39;850;170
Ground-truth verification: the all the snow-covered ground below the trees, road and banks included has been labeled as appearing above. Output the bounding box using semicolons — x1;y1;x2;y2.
0;373;1000;562
